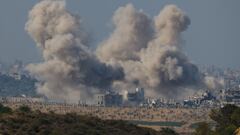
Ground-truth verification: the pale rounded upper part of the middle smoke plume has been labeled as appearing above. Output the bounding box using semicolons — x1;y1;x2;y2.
97;4;152;62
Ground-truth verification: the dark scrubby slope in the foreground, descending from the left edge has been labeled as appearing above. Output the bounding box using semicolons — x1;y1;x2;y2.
0;105;177;135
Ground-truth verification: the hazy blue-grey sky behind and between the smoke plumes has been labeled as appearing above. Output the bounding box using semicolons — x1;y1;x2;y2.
0;0;240;68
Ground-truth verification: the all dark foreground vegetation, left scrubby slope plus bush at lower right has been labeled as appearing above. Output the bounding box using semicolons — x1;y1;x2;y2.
0;104;240;135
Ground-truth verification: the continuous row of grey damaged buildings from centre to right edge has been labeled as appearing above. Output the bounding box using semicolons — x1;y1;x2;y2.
94;86;240;108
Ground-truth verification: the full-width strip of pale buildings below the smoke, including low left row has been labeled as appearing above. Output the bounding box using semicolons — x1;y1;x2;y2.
0;86;240;108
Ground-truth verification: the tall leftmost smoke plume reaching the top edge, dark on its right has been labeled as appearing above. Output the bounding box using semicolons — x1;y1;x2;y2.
26;0;124;100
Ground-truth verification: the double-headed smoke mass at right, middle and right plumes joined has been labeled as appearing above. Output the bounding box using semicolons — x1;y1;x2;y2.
97;4;223;97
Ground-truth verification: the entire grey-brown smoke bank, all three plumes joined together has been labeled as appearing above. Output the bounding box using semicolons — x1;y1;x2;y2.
26;0;223;99
